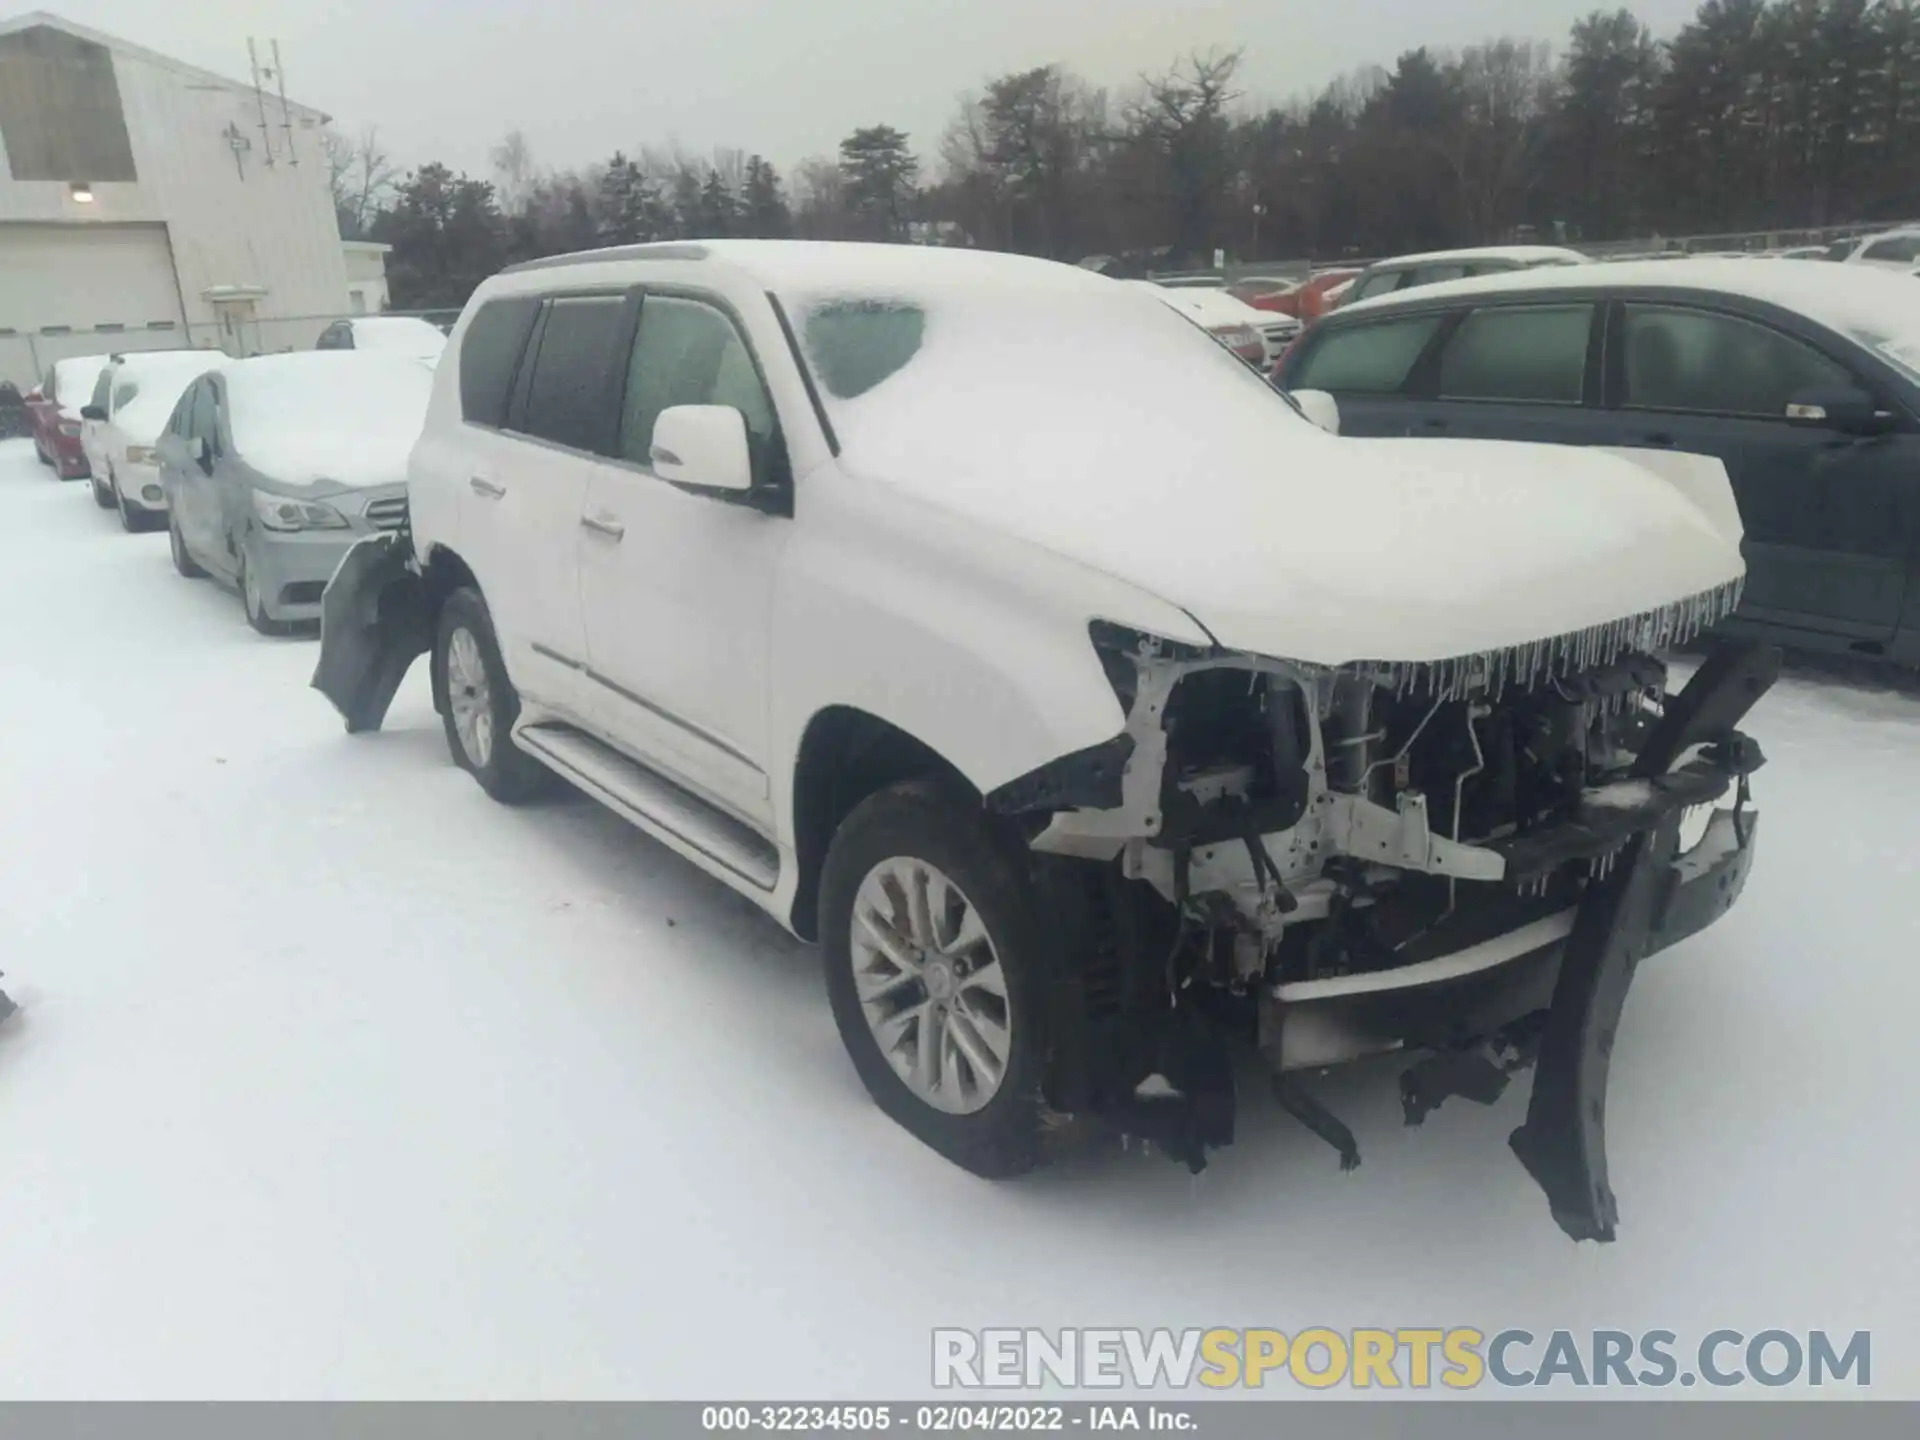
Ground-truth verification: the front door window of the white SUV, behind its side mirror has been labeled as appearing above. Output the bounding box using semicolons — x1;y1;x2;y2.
618;296;780;480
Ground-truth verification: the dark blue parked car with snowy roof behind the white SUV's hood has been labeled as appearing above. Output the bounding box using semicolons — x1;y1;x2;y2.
1277;259;1920;664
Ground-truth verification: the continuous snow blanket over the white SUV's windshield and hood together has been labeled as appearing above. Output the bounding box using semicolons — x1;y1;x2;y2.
801;261;1743;664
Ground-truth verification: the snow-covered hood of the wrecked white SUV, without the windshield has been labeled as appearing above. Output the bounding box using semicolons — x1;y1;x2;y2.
847;374;1745;664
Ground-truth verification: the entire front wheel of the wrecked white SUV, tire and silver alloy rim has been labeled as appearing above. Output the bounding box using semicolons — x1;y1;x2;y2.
820;781;1046;1179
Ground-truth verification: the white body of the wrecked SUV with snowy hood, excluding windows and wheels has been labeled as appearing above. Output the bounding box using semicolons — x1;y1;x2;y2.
411;242;1741;936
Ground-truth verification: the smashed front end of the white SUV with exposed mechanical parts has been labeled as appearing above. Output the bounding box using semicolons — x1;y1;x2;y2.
987;586;1778;1240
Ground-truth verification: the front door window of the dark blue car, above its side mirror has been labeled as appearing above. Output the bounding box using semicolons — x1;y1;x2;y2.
1622;305;1857;419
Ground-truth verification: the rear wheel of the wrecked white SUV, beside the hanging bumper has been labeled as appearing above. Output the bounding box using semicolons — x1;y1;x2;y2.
434;586;553;804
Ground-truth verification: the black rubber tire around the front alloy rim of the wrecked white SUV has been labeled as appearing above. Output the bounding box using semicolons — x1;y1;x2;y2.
820;780;1056;1179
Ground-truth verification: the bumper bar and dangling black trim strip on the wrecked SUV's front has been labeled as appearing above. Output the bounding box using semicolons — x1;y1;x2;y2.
1261;647;1780;1242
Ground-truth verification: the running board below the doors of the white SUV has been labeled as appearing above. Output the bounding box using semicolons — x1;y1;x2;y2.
513;722;780;891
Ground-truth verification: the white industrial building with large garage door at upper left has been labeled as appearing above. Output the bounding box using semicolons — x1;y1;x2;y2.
0;12;366;390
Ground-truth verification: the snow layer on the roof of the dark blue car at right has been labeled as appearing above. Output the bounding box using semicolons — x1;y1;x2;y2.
1340;257;1920;340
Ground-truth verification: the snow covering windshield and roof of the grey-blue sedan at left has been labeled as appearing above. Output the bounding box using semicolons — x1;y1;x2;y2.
221;349;434;486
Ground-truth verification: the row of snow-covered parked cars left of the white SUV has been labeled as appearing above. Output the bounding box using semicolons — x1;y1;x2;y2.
27;315;445;634
